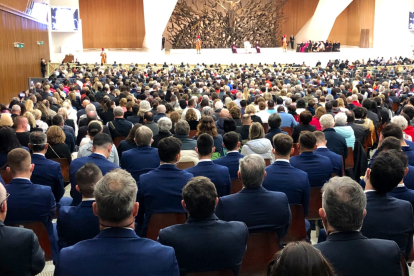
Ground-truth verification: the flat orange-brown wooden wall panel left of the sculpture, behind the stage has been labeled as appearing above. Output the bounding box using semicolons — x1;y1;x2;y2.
79;0;146;49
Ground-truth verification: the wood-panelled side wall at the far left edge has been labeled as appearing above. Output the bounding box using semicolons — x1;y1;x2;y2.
0;10;49;104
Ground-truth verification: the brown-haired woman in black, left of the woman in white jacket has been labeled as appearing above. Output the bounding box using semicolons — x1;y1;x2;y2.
45;126;72;164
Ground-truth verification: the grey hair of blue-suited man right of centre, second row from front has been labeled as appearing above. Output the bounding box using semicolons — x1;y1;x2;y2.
239;154;266;188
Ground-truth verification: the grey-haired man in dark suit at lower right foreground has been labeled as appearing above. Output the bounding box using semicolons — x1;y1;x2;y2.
315;177;402;276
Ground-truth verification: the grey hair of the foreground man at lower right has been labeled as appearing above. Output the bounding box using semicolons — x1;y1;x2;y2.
322;176;367;231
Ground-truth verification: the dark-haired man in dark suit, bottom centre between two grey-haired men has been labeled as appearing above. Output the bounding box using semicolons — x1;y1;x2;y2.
158;176;249;275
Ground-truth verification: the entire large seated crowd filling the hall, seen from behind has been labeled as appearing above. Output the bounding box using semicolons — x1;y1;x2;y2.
0;57;414;276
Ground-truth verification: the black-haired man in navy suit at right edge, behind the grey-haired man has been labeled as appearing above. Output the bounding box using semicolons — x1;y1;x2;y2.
361;150;414;258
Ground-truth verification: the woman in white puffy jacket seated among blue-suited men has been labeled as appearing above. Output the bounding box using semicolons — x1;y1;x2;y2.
241;123;274;163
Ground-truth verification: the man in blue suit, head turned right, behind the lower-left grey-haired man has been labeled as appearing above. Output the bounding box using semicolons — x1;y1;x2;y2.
69;133;119;206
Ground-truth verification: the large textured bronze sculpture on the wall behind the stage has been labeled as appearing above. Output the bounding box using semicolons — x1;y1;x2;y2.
167;0;288;49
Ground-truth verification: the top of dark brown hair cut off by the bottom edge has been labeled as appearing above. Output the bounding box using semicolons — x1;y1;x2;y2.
267;242;335;276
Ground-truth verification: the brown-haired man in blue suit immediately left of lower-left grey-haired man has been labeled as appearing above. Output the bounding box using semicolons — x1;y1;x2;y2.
57;163;102;249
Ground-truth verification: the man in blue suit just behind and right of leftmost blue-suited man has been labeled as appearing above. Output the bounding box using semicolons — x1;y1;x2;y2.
29;131;64;204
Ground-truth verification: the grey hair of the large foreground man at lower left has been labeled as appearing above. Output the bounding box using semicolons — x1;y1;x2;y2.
93;169;138;223
